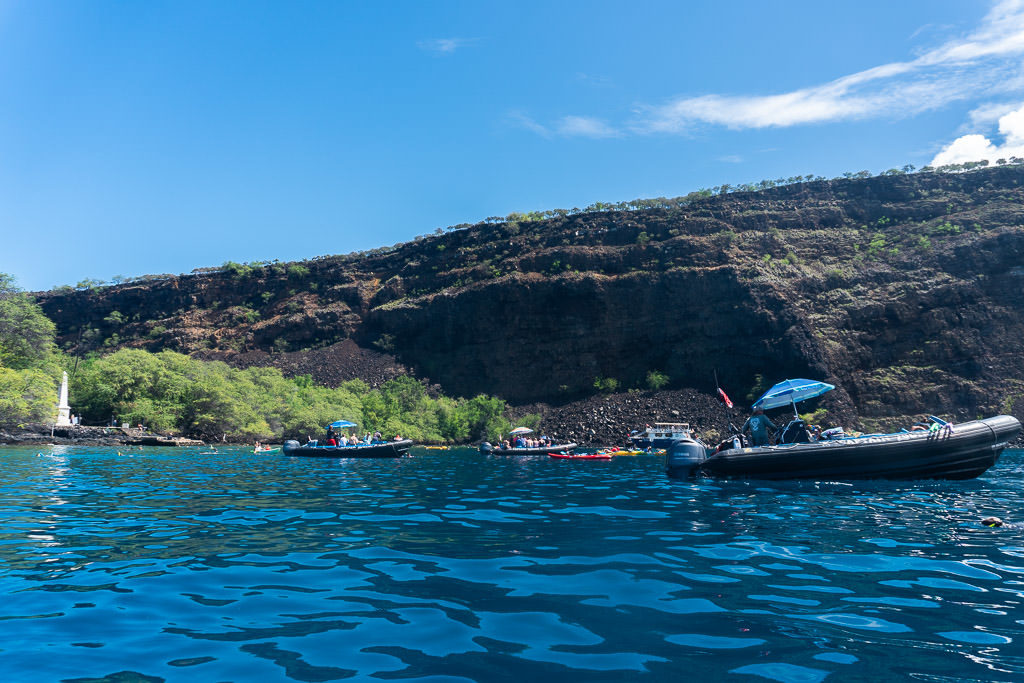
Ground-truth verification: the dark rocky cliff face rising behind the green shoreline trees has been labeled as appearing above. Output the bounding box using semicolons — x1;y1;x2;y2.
40;167;1024;427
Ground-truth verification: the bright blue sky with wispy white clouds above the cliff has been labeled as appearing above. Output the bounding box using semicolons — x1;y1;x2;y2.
0;0;1024;290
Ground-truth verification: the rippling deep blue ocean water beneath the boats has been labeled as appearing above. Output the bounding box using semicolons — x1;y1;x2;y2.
0;446;1024;683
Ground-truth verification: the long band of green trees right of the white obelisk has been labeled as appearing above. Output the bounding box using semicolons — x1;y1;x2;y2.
73;349;507;442
